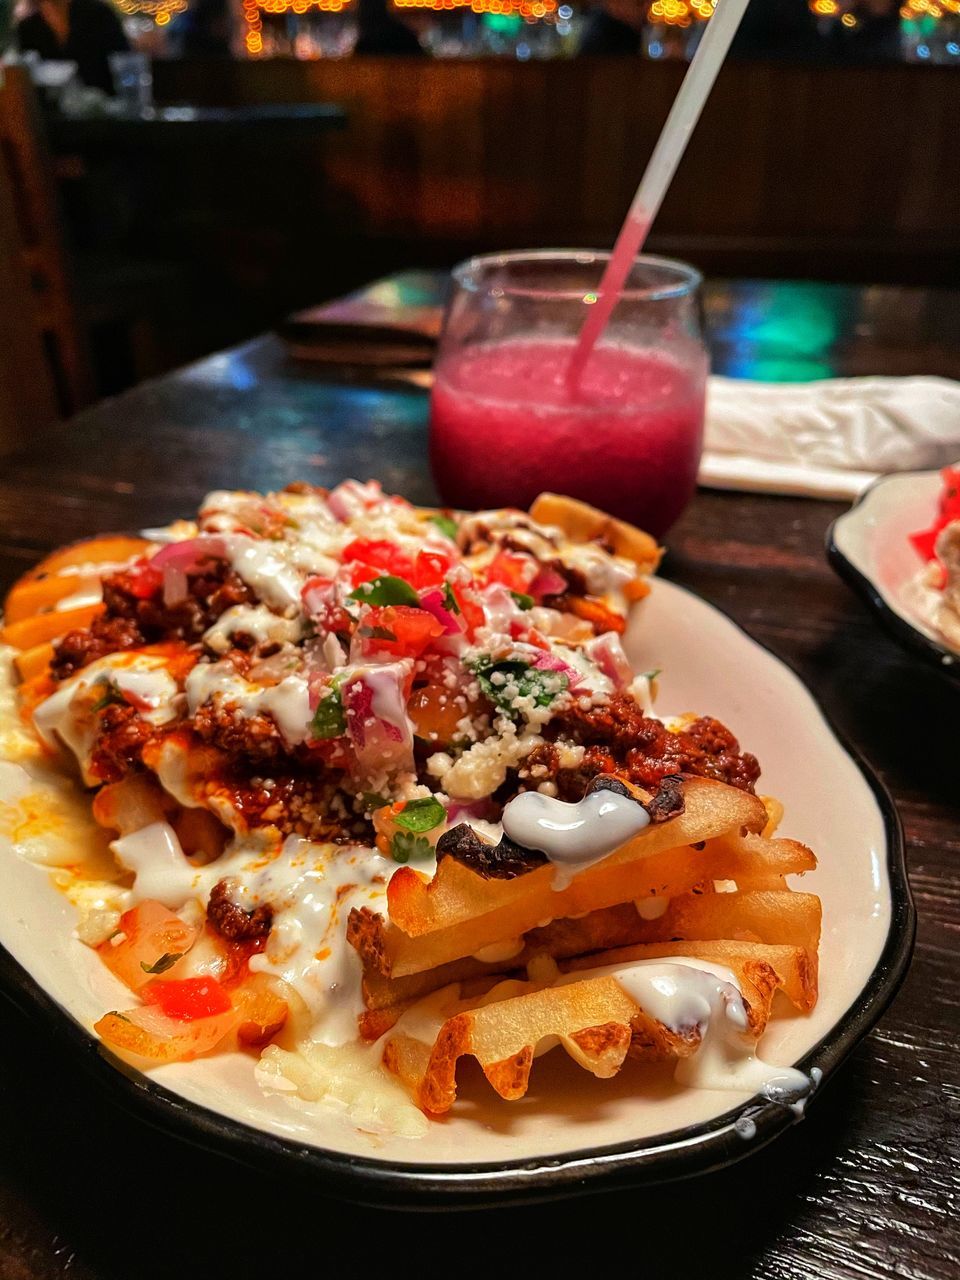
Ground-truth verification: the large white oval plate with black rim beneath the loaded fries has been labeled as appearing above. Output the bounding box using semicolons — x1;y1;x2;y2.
0;581;914;1207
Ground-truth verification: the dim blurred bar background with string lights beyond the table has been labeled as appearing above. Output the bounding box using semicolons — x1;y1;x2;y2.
0;0;960;420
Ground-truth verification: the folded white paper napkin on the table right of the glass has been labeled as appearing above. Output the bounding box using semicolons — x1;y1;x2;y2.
700;376;960;498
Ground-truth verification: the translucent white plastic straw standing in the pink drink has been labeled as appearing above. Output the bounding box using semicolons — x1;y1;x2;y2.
568;0;749;387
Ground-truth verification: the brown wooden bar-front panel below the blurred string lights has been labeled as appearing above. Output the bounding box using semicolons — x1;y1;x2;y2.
156;59;960;276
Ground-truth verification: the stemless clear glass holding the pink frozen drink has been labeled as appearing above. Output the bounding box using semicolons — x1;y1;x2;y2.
430;250;708;535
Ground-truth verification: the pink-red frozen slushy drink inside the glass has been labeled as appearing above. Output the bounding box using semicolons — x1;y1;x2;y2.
430;337;707;535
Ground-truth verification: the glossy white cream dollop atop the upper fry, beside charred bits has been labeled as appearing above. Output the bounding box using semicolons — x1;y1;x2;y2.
503;791;650;891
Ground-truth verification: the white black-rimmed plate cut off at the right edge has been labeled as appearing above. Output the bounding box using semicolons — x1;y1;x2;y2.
827;471;960;680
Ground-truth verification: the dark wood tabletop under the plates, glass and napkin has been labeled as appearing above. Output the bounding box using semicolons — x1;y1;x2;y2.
0;275;960;1280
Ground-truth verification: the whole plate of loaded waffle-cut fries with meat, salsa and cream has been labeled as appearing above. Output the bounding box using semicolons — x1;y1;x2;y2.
0;480;914;1207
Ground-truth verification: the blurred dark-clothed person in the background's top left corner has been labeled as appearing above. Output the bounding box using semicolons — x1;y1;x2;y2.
17;0;131;93
